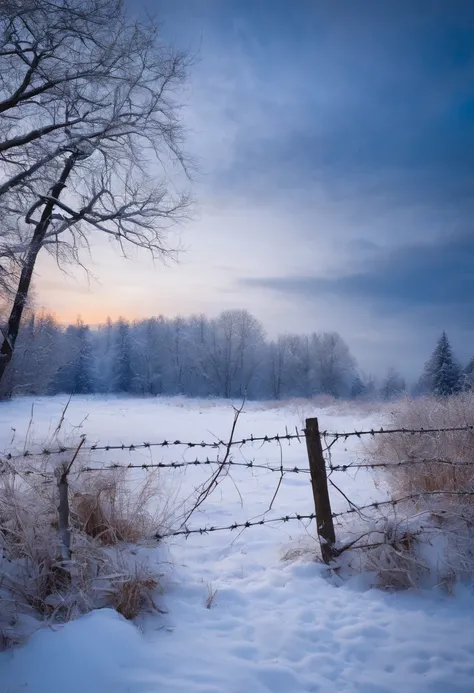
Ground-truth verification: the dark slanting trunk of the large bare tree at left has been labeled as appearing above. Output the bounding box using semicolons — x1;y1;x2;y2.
0;154;77;383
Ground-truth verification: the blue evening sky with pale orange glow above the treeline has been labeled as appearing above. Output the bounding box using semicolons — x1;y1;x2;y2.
38;0;474;375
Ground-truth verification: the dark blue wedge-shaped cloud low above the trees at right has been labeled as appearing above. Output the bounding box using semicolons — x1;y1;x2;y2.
242;232;474;330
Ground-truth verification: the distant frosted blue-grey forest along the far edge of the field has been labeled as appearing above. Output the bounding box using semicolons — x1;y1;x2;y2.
0;310;474;400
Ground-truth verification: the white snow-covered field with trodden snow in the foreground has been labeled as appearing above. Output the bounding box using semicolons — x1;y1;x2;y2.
0;397;474;693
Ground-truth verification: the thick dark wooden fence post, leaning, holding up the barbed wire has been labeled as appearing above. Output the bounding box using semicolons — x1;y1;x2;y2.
305;418;336;563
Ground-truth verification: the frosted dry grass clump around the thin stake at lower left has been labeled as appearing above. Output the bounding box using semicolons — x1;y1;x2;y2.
0;459;166;646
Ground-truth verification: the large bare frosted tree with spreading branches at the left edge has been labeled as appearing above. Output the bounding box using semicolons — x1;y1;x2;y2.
0;0;193;379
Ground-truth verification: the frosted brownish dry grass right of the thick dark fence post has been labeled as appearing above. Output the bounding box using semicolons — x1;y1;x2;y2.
349;394;474;590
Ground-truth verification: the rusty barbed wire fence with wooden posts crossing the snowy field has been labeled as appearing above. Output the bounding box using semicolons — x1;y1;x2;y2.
0;416;474;563
